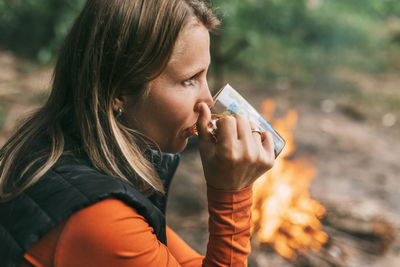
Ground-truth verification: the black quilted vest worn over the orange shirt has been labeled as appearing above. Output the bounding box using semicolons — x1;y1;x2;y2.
0;152;179;267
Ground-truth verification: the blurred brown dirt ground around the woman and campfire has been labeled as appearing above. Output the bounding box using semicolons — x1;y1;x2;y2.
0;49;400;267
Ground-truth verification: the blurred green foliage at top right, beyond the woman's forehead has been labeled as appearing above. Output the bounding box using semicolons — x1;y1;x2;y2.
212;0;400;82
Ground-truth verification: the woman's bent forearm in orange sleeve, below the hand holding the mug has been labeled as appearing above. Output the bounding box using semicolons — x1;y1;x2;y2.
167;187;252;267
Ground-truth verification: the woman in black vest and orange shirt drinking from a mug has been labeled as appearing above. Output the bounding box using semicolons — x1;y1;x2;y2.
0;0;274;266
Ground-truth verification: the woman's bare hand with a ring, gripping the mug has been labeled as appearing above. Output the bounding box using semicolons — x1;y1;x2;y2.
197;103;275;190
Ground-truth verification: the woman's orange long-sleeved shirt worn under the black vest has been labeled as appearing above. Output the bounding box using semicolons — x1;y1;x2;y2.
20;186;252;267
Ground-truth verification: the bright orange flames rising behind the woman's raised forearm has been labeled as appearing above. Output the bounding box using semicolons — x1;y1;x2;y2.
253;100;328;258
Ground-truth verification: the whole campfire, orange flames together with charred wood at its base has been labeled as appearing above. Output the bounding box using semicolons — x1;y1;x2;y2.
252;100;396;266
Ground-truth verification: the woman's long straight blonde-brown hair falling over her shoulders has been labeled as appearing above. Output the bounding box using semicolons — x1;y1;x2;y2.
0;0;219;201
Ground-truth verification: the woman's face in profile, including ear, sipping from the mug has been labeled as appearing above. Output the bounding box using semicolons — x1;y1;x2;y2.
121;24;213;153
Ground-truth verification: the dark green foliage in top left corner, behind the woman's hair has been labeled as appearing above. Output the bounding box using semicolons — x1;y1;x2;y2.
0;0;84;63
